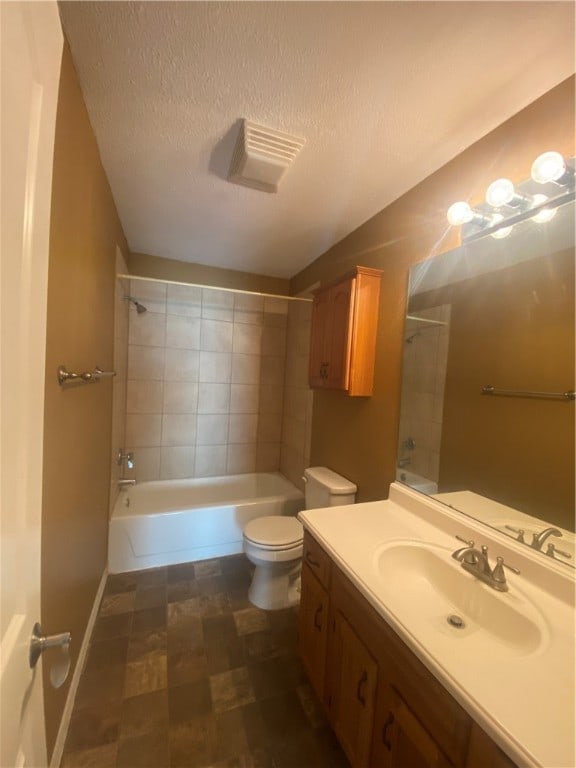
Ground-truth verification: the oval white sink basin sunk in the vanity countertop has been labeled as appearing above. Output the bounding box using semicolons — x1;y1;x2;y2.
373;541;548;657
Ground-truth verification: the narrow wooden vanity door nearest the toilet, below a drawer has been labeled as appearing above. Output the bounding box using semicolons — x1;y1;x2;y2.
298;564;329;700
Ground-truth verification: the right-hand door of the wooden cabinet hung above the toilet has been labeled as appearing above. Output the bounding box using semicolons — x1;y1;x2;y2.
325;278;356;390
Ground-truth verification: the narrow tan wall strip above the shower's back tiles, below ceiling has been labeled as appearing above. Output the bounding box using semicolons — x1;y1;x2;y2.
127;253;290;296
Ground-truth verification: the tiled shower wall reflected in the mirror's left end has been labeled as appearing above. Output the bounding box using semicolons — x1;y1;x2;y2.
398;304;450;482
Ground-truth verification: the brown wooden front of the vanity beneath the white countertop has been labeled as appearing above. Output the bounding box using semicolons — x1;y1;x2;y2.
299;532;515;768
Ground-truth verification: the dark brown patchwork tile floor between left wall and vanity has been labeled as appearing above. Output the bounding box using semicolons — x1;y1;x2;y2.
61;555;348;768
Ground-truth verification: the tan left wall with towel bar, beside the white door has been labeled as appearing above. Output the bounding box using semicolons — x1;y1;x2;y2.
42;46;127;753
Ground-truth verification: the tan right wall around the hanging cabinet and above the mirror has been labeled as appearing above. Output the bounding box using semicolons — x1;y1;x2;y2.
290;77;575;501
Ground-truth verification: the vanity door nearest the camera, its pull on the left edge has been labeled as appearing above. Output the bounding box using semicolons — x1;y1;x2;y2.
371;686;450;768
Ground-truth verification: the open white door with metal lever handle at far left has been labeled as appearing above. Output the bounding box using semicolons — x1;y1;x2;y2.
0;0;62;768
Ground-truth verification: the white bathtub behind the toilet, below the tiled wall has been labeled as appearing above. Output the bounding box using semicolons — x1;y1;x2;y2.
108;472;304;573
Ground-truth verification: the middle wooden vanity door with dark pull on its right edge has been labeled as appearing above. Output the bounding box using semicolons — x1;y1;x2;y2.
328;611;378;768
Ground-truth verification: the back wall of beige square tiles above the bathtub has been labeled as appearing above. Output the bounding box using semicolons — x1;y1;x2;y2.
120;280;305;481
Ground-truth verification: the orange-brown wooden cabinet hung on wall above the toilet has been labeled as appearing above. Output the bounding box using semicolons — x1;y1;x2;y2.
309;267;382;396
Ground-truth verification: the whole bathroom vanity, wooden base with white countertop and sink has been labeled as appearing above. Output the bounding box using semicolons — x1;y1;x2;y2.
299;485;575;768
